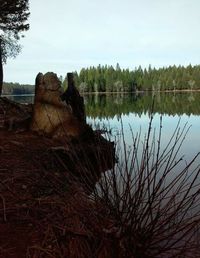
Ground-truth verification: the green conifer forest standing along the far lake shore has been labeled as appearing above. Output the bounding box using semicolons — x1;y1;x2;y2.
3;64;200;95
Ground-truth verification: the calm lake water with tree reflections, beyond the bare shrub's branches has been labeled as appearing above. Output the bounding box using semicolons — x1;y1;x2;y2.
5;92;200;164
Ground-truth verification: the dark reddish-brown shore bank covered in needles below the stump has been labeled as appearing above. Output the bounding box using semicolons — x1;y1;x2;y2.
0;95;116;258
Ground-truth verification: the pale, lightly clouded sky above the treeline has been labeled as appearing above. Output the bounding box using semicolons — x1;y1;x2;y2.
4;0;200;84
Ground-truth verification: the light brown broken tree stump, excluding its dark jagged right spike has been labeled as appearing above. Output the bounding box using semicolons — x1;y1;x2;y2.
31;72;85;138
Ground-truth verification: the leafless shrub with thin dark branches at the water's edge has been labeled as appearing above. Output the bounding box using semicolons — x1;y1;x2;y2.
92;116;200;258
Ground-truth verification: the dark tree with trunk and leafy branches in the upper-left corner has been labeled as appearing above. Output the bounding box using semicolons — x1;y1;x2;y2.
0;0;30;94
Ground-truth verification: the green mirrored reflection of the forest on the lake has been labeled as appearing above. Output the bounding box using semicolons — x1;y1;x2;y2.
85;93;200;118
